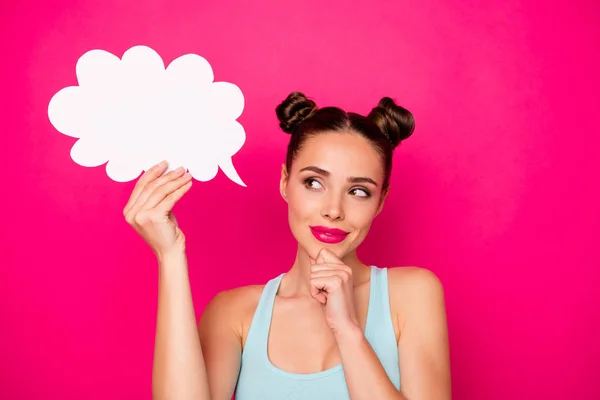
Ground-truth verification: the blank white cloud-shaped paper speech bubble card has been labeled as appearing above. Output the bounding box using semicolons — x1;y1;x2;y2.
48;46;246;186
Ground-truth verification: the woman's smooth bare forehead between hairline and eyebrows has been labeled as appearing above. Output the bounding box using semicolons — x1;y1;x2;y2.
293;132;383;179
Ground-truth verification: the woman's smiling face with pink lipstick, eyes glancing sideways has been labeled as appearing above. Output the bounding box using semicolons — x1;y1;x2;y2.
281;133;384;258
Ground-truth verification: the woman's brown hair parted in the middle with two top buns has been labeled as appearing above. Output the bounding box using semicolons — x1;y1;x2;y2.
275;92;415;191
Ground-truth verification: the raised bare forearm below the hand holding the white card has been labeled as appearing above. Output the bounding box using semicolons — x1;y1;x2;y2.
152;253;210;400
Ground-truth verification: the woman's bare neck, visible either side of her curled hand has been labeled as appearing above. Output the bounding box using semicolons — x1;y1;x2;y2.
278;246;371;297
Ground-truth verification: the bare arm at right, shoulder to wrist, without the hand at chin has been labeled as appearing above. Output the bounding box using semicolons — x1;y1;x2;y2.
336;268;451;400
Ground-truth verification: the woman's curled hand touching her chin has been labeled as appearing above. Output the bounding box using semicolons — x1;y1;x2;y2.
310;249;359;334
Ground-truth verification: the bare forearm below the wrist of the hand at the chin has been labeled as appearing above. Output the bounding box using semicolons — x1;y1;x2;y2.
336;327;407;400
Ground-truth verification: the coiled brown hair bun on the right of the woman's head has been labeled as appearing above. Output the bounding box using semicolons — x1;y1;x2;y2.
367;97;415;148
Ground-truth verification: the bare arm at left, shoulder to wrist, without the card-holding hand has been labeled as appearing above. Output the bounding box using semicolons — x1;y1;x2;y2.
152;255;244;400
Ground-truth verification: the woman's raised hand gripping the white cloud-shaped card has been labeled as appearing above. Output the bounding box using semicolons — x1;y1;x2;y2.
123;161;192;258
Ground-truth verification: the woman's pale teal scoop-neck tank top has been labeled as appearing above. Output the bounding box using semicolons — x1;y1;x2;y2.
235;266;400;400
